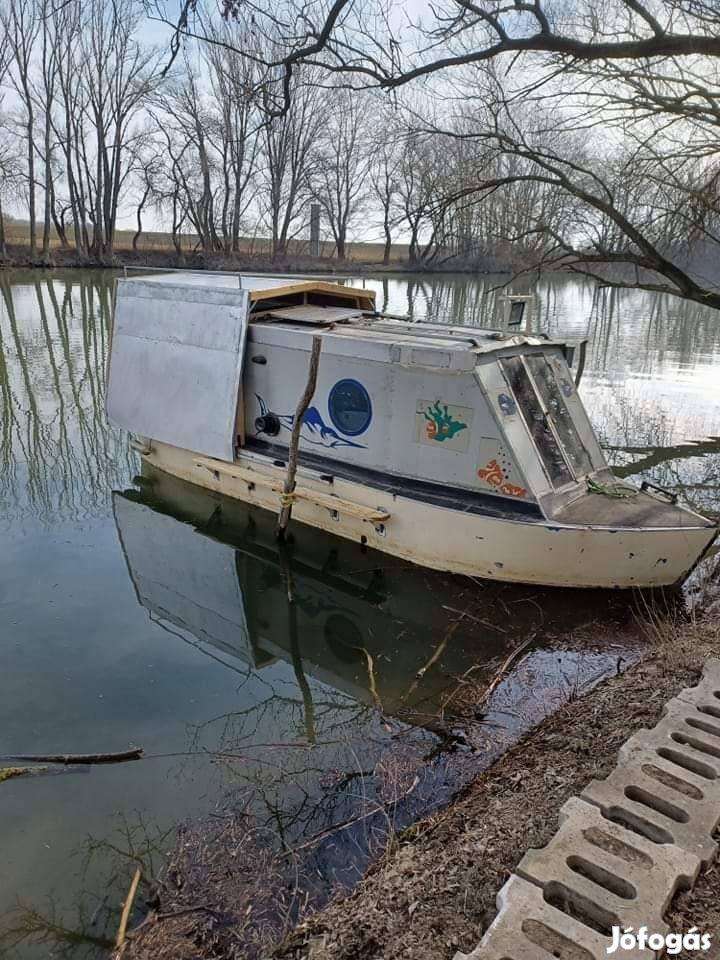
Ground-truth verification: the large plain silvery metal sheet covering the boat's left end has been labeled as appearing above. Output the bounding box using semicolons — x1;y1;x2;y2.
106;280;248;460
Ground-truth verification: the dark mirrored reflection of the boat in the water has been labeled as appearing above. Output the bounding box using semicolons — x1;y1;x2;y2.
114;466;648;732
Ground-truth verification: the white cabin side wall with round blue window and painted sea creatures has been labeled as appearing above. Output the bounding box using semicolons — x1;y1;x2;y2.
244;336;533;501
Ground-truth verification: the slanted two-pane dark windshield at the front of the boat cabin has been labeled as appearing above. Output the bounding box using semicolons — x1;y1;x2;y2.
500;353;592;488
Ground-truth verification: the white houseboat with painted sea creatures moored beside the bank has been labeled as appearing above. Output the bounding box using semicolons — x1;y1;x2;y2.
106;273;717;587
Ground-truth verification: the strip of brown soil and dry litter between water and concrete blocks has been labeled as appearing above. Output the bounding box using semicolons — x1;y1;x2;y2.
273;621;720;960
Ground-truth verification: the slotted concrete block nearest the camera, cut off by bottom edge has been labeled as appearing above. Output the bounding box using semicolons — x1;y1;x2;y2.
454;876;656;960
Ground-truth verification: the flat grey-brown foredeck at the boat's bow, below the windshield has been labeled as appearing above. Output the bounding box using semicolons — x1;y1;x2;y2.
553;492;713;529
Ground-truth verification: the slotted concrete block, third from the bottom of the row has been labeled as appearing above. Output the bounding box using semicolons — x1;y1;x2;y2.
581;688;720;864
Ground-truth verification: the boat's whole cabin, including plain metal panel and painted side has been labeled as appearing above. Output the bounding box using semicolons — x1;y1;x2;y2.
108;274;607;516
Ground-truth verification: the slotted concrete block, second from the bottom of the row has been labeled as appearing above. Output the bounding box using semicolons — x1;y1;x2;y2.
515;797;700;934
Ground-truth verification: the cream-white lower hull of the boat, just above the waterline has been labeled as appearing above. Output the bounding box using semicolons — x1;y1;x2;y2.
143;441;716;588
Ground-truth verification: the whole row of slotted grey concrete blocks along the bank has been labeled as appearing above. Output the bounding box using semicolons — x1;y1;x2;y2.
455;659;720;960
